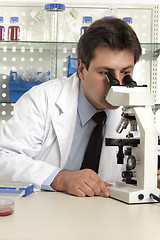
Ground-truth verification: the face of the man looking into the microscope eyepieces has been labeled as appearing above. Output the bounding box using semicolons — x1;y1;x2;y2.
78;47;134;109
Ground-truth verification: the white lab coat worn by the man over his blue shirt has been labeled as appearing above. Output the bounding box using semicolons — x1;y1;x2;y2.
0;74;129;188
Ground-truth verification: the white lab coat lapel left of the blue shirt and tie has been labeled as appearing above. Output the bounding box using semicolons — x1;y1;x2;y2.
52;77;79;168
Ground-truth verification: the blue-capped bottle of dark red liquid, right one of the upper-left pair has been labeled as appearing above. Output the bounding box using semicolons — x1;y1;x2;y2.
8;17;20;41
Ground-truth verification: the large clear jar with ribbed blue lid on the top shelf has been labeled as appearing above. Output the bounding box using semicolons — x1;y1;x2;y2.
44;3;65;42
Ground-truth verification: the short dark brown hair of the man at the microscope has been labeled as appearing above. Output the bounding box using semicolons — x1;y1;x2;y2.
77;17;142;70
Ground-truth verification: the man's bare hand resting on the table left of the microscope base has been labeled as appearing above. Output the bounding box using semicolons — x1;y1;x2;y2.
51;169;109;197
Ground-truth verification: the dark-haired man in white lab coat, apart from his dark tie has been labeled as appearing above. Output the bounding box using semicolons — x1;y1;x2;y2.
0;18;141;197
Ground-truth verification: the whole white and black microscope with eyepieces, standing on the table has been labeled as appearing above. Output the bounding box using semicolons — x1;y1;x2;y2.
105;73;160;204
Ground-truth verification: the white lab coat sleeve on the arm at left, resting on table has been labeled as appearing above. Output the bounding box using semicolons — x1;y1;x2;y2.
0;86;57;189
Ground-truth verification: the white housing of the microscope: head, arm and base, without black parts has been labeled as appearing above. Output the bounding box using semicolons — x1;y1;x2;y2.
106;79;160;204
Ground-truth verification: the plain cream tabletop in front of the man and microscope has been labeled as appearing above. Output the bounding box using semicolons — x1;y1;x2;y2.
0;191;160;240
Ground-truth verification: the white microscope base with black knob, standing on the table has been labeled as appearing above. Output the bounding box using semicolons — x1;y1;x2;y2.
108;182;160;204
